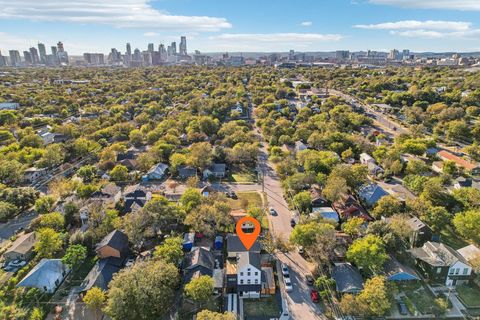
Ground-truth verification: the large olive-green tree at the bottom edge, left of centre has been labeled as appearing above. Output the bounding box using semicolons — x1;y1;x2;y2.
105;260;179;320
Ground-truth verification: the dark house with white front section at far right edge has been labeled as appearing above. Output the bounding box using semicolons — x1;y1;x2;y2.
409;241;472;287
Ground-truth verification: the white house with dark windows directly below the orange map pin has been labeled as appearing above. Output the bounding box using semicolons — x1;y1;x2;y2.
237;252;262;298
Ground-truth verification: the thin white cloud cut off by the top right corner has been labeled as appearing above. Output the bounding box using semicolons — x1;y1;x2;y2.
369;0;480;11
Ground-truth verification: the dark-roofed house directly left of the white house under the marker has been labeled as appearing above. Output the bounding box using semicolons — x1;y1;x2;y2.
183;247;215;283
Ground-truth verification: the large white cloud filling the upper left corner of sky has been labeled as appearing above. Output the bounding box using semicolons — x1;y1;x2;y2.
0;0;232;31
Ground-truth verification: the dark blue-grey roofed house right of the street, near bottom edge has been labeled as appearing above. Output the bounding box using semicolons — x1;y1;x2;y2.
332;263;363;294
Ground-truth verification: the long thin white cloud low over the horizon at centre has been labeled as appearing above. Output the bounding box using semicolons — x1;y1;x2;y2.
210;33;343;44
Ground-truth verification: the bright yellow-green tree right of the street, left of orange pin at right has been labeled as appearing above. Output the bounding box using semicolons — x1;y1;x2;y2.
347;234;388;272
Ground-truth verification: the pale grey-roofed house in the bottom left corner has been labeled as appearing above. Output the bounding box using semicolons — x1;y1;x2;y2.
17;259;70;293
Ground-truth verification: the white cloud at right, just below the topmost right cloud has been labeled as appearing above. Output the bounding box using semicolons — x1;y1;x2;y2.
353;20;472;31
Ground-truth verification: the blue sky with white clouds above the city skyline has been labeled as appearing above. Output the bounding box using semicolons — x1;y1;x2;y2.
0;0;480;54
